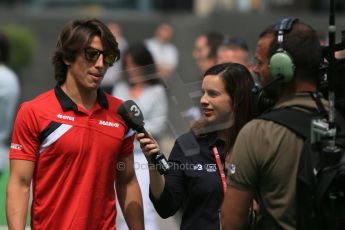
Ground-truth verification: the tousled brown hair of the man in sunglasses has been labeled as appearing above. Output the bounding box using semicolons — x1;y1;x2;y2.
52;19;120;85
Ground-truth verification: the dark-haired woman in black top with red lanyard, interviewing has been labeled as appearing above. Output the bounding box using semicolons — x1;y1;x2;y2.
137;63;254;230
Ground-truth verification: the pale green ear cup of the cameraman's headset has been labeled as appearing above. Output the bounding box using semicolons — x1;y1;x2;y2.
269;51;295;83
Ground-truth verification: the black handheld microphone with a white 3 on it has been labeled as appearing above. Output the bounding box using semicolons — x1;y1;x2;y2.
117;100;170;175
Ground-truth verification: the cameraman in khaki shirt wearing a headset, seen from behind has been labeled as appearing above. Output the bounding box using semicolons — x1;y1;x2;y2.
222;18;325;229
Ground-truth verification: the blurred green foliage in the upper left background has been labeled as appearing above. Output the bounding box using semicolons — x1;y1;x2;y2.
0;24;37;72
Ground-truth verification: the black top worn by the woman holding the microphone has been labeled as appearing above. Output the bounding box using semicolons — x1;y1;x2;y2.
150;133;224;230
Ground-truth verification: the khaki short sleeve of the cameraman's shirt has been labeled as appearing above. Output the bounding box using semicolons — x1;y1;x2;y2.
227;122;263;191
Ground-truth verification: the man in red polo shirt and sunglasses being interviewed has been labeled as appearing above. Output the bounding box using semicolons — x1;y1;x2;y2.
6;19;144;230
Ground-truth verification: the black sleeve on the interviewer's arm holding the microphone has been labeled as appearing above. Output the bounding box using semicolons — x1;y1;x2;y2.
150;139;187;218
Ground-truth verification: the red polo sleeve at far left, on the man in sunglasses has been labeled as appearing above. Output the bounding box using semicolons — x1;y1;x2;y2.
9;103;40;161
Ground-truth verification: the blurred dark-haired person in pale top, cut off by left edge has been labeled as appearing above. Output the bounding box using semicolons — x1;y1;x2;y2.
0;32;20;177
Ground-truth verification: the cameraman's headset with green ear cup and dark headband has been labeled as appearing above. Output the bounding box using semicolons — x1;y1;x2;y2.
269;17;298;83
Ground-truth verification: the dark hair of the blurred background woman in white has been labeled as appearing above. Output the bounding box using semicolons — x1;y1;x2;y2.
122;42;161;85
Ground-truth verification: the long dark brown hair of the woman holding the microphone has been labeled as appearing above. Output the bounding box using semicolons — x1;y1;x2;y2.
191;63;254;154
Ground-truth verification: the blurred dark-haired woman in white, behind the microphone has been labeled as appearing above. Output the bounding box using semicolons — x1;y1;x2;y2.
112;43;168;230
